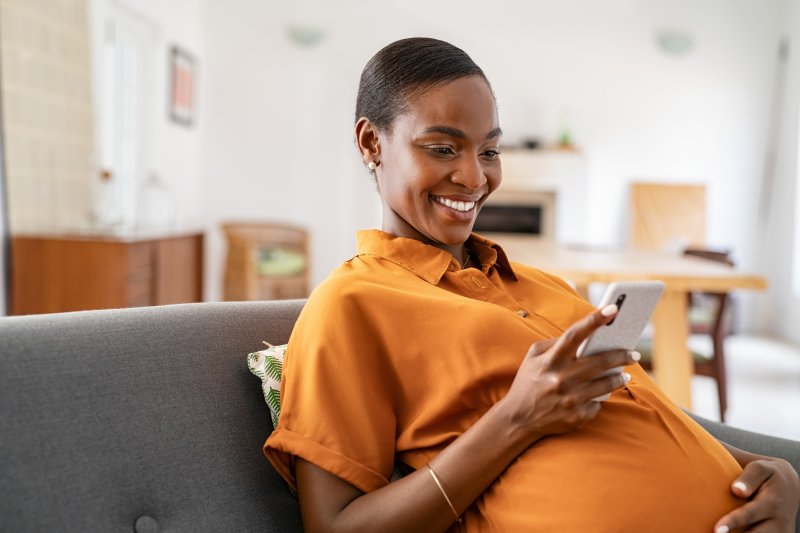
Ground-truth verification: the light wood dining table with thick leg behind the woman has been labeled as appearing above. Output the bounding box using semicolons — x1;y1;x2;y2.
494;233;767;410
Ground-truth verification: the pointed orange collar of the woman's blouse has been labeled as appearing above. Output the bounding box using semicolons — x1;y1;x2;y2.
356;230;517;285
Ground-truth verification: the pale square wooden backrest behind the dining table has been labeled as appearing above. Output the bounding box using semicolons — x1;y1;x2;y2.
630;182;706;252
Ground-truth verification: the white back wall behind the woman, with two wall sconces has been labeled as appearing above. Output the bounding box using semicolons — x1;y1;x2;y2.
202;0;783;324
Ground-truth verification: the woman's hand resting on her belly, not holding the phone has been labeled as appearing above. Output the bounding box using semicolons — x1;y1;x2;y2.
714;458;800;533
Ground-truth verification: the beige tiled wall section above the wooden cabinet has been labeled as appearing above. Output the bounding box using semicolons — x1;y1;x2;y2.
0;0;96;232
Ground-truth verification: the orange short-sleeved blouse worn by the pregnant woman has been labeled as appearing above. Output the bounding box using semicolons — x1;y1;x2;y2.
264;230;741;532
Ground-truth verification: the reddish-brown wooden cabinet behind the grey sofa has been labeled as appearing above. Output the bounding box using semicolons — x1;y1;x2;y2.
11;232;203;315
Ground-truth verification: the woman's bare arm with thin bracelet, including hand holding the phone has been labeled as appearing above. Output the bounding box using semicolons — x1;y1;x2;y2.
296;304;634;532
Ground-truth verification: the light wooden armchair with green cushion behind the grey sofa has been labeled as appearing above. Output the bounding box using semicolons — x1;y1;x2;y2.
222;222;309;300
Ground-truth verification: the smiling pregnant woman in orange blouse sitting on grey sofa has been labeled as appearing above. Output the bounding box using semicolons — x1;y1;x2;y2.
264;38;800;533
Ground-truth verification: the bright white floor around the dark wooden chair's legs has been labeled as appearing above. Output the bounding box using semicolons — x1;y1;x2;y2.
692;335;800;441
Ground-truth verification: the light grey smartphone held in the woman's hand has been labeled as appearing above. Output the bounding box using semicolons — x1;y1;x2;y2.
578;281;664;401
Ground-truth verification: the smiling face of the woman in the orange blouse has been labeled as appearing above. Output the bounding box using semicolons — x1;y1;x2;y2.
368;76;502;251
